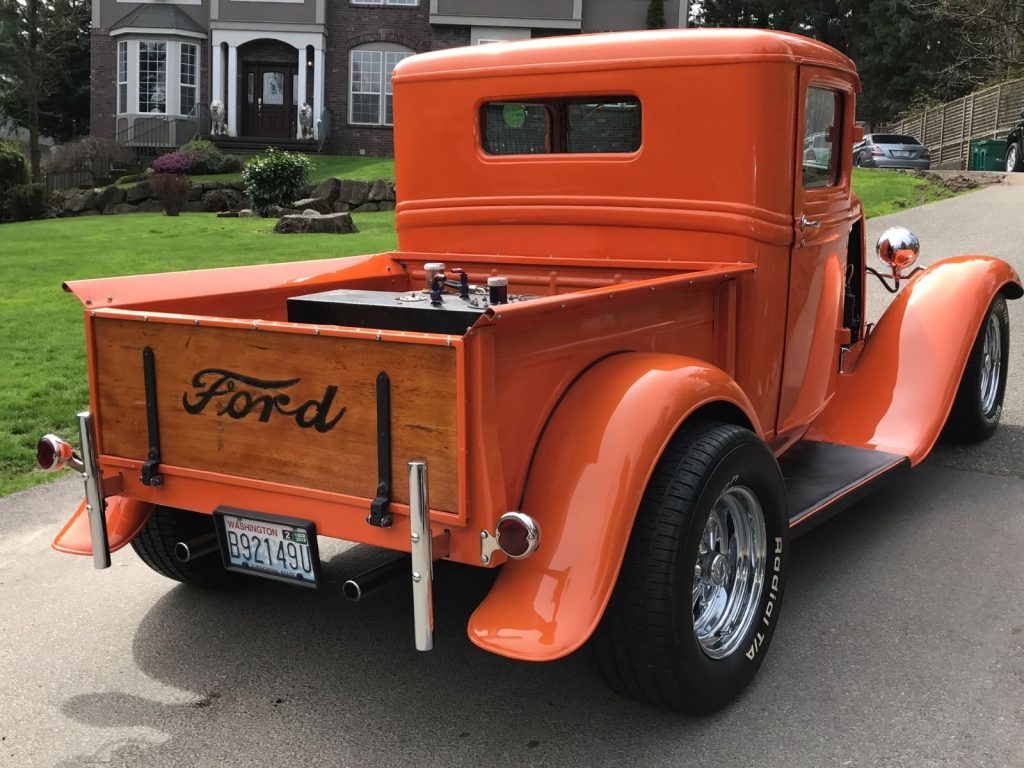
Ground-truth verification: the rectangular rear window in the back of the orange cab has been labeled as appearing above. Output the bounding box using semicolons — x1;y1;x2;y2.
480;96;642;155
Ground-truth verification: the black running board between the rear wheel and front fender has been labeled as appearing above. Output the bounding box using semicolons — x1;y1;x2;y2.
778;440;910;535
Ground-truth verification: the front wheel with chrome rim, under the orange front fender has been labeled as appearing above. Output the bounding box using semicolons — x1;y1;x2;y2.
945;294;1010;443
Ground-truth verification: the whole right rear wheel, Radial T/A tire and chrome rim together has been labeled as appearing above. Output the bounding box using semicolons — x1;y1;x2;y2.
594;422;788;714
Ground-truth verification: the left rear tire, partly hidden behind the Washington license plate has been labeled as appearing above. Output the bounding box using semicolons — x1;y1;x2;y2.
131;507;247;590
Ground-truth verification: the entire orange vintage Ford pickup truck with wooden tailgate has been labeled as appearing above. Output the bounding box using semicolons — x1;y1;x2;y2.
39;30;1022;712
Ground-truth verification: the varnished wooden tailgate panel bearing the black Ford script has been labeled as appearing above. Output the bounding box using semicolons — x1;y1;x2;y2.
94;317;459;512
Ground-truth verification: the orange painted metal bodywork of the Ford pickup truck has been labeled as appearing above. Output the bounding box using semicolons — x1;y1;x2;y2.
55;30;1019;660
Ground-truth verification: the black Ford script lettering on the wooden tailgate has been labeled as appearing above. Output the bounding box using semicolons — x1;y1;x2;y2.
181;368;345;432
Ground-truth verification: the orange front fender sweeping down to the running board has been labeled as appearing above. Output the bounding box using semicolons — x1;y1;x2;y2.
807;256;1022;465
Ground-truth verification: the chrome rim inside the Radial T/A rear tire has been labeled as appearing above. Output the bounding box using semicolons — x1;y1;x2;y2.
692;485;766;658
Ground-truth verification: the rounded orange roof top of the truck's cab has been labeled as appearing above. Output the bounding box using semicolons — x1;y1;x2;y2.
394;29;856;80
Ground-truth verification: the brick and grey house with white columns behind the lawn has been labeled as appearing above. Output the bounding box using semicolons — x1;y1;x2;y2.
91;0;687;155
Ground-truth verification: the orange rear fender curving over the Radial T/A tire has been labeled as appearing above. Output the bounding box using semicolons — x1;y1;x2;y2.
467;353;761;662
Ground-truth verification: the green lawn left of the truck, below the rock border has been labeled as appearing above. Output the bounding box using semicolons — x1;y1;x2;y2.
0;213;395;496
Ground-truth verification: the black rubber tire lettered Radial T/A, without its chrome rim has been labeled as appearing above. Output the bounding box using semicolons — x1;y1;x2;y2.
594;422;788;714
